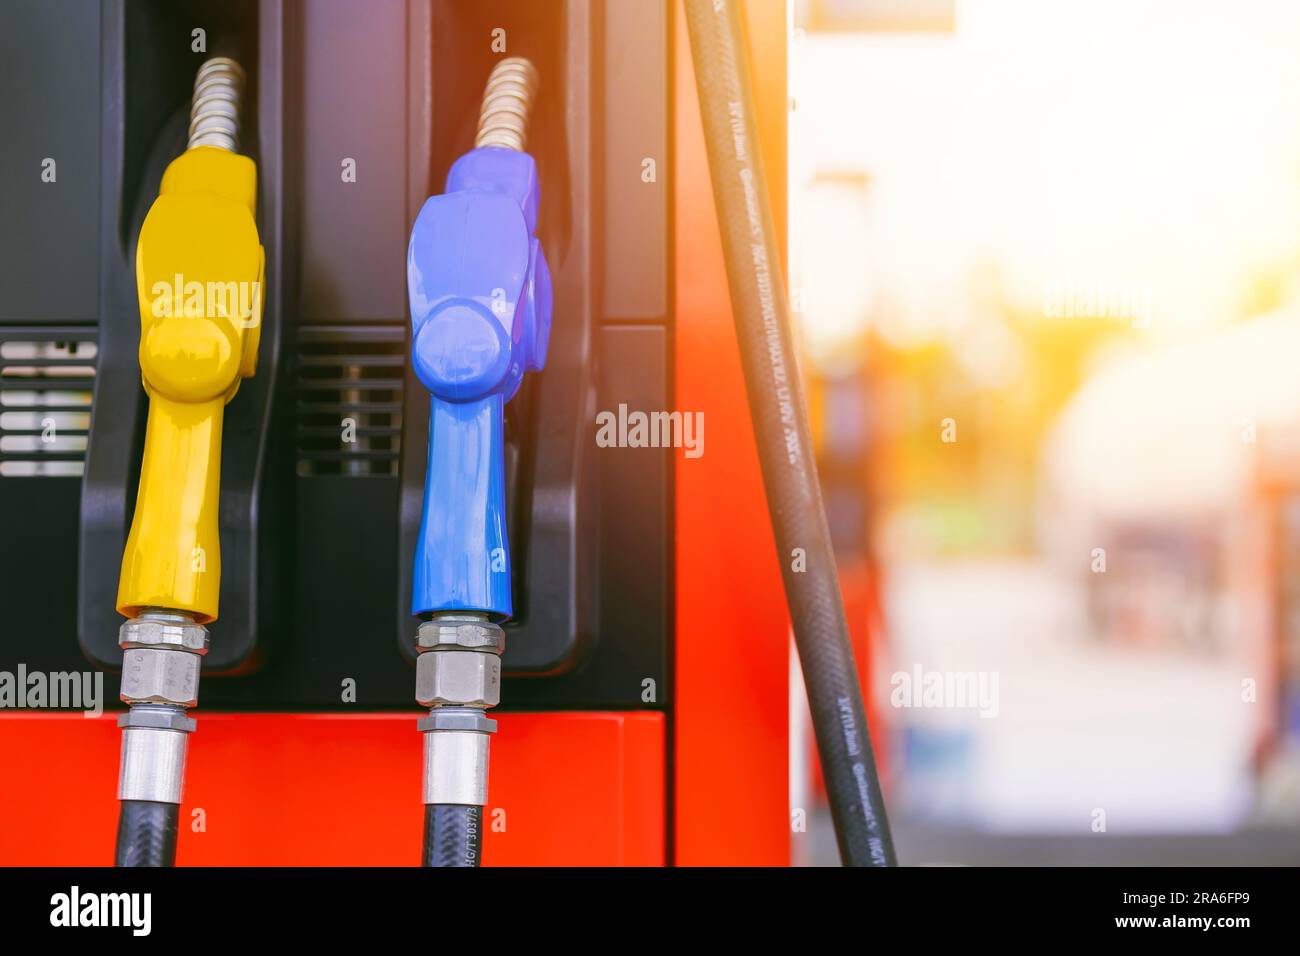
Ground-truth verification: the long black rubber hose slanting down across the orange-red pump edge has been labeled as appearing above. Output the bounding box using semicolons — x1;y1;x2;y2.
686;0;896;866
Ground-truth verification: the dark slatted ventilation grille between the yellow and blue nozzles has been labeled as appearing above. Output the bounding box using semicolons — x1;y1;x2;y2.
298;325;406;477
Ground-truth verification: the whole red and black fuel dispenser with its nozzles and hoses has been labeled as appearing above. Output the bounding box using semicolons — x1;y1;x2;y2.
0;0;892;865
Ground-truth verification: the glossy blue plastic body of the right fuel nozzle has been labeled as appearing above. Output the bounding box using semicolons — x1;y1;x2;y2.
407;147;551;618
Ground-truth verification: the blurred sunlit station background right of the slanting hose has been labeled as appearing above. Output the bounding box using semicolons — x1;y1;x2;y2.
789;0;1300;864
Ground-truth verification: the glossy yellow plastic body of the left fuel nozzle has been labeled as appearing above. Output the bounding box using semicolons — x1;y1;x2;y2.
117;146;265;623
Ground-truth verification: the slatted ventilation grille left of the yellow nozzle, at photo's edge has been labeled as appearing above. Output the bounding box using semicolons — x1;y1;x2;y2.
0;329;98;477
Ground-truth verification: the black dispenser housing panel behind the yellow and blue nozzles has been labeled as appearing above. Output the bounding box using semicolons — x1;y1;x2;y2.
0;0;672;710
